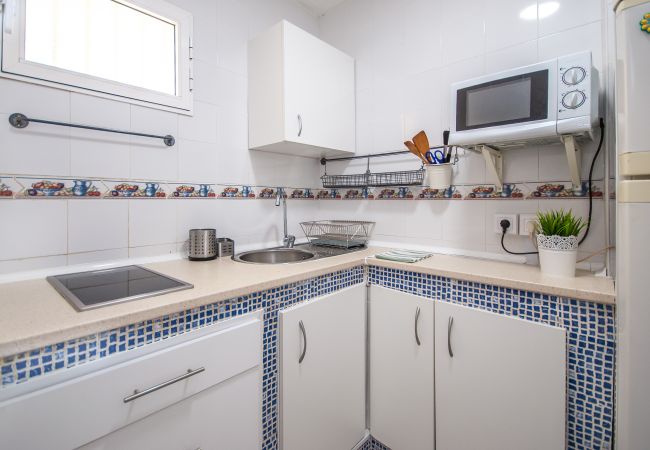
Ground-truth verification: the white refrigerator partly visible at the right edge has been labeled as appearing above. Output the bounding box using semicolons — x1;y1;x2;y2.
615;0;650;450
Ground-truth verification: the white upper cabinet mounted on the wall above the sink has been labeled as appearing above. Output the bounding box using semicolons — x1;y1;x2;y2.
248;21;355;157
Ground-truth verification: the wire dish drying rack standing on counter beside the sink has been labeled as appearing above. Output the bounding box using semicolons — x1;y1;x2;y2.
300;220;375;249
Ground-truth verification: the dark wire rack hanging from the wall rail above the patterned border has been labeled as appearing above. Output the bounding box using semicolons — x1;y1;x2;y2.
320;145;450;189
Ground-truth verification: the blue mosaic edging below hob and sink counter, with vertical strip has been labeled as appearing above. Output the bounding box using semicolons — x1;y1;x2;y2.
0;266;364;450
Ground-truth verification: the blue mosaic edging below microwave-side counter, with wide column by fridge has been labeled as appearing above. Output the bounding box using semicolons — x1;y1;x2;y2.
369;266;616;450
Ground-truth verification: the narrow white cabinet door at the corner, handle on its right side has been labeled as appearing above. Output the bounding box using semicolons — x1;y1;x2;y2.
369;286;435;450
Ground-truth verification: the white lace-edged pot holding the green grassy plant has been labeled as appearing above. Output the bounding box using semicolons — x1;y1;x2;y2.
537;234;578;277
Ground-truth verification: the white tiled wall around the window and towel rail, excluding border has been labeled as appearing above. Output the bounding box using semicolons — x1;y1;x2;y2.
0;0;319;273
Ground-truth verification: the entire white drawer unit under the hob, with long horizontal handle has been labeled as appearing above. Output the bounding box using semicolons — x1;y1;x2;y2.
0;313;262;450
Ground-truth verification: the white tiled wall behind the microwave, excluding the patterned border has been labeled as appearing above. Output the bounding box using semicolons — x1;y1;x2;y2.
320;0;613;261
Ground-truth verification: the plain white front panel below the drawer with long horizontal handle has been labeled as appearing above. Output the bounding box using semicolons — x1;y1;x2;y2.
79;366;262;450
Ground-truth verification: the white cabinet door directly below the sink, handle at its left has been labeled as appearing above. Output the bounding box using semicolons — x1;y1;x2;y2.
280;285;366;450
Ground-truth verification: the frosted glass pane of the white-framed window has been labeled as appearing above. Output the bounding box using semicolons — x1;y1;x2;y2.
25;0;176;95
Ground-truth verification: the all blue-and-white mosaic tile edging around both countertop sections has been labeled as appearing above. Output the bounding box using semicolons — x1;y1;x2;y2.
0;266;615;450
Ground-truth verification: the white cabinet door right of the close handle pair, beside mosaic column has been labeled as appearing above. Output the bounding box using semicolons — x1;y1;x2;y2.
435;302;566;450
